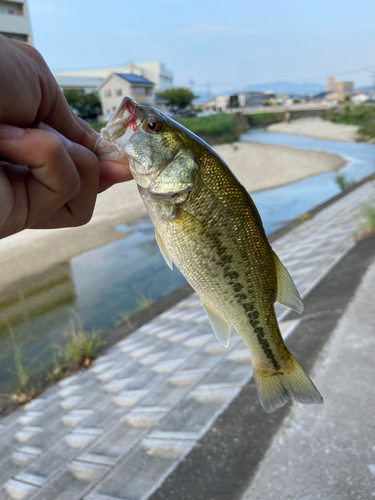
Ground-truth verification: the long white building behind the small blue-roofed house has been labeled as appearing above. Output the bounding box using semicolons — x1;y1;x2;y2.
54;61;173;91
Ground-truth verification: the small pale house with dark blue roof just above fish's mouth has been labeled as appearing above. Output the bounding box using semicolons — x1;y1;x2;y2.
98;73;155;118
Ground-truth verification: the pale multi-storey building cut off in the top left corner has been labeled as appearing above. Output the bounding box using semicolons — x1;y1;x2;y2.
0;0;33;44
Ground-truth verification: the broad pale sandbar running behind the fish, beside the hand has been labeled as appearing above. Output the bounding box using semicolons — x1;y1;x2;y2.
0;124;345;294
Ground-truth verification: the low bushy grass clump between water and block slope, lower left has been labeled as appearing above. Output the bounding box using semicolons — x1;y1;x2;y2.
63;331;104;367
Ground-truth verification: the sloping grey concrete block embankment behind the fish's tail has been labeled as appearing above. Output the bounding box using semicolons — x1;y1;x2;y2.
0;183;375;500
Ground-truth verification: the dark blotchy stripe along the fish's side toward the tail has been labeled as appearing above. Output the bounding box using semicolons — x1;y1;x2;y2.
210;230;281;370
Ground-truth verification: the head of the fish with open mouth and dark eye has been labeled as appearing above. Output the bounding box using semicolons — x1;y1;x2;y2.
96;97;187;189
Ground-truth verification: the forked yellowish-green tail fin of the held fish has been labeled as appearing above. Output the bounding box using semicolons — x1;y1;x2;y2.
253;354;323;413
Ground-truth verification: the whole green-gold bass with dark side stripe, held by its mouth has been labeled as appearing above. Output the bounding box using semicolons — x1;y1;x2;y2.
97;97;323;413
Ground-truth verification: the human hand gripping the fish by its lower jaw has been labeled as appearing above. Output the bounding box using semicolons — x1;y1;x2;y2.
0;36;131;237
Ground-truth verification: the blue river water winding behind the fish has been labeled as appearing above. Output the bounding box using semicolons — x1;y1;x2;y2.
0;130;375;394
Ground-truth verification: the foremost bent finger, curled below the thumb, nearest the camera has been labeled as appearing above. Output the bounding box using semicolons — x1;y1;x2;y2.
0;125;80;226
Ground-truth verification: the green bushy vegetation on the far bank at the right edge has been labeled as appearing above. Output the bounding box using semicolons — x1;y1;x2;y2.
322;104;375;140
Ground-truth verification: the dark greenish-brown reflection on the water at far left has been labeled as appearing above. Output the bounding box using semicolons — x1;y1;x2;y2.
0;262;77;393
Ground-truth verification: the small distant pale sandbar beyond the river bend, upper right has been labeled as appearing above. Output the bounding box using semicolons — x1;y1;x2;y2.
267;117;358;142
